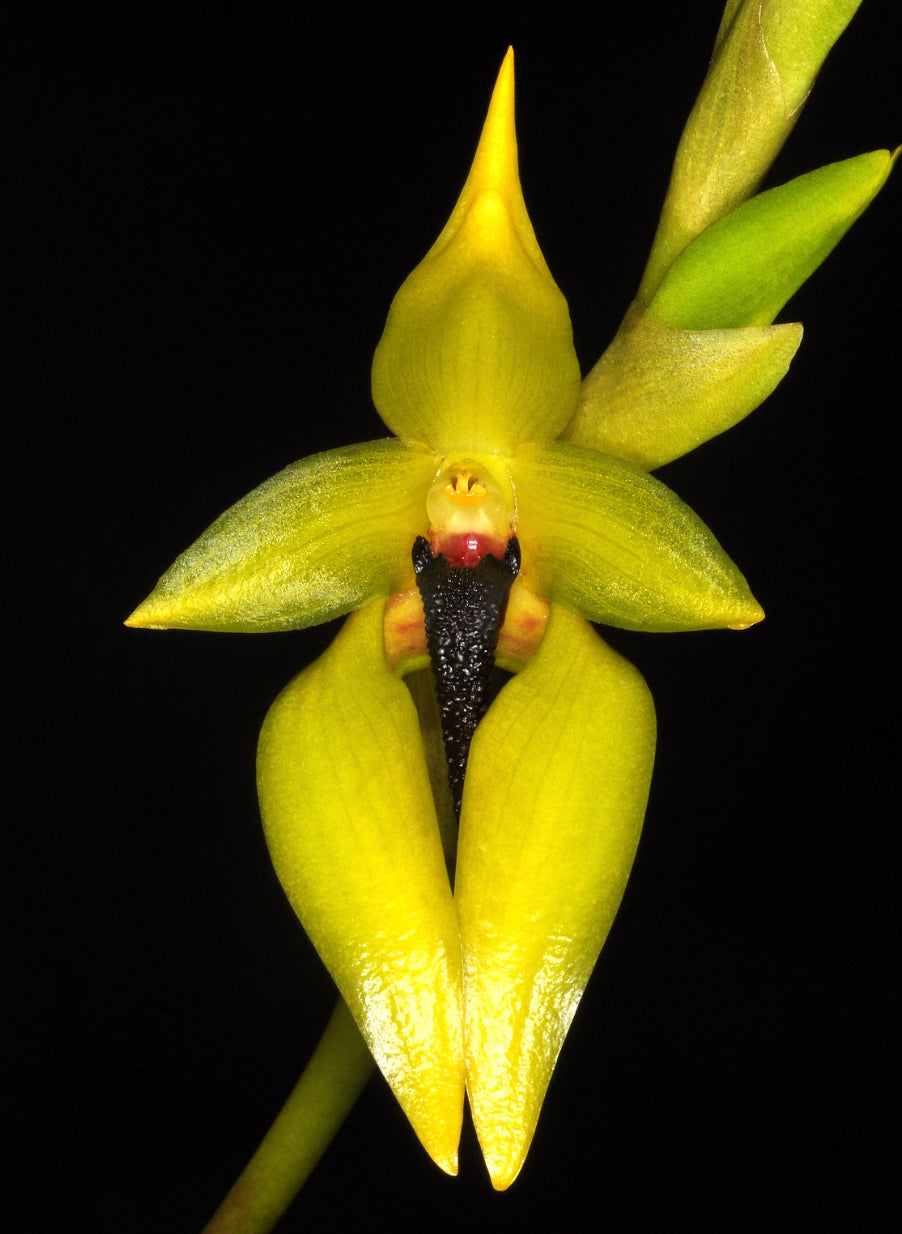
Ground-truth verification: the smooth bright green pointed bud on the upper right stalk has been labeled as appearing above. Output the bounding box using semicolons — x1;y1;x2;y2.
649;151;893;329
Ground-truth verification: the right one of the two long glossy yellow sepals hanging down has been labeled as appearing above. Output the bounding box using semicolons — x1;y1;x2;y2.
454;606;655;1190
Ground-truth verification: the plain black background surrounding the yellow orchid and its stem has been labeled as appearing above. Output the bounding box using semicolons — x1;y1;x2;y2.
17;2;900;1234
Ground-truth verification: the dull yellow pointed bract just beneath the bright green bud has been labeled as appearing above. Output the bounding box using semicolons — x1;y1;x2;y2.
563;301;802;470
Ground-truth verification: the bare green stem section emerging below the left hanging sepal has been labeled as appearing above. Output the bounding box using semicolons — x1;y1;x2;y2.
202;1000;375;1234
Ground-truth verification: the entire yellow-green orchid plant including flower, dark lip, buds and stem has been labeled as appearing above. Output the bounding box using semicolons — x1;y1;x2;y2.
128;0;892;1230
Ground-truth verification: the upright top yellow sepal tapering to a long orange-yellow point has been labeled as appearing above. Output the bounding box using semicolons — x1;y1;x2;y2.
373;52;580;454
